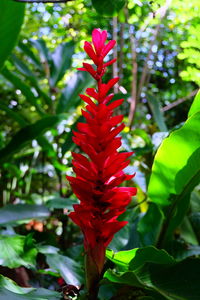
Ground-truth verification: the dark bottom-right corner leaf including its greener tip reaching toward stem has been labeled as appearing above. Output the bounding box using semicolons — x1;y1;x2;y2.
104;259;200;300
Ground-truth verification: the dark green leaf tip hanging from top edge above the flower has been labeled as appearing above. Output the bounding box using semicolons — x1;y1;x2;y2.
92;0;126;16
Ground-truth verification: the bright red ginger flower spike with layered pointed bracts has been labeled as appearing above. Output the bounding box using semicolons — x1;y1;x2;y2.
67;29;136;288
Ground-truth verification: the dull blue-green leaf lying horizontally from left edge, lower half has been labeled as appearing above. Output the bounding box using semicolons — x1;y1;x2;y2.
0;204;50;225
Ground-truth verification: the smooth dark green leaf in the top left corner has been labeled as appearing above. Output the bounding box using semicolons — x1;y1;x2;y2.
0;0;25;69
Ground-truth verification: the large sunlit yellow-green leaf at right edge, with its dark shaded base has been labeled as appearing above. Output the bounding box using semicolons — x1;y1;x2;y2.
148;112;200;246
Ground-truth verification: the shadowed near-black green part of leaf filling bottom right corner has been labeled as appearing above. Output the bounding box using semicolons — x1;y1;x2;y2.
137;259;200;300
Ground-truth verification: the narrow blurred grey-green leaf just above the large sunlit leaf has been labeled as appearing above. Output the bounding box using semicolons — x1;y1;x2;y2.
147;93;167;131
